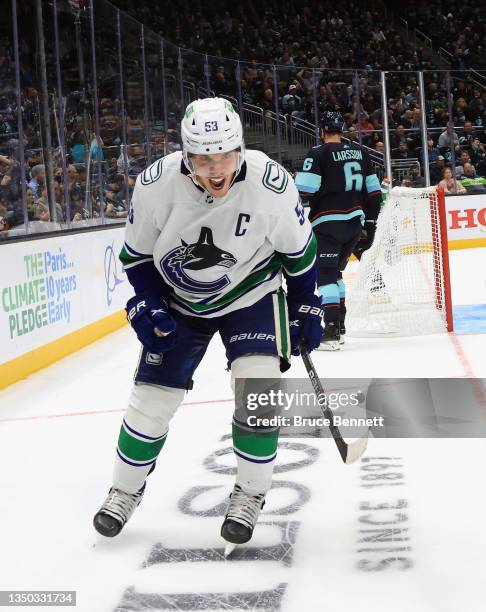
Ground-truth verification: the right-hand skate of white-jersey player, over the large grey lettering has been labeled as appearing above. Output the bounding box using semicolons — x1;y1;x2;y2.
221;485;265;544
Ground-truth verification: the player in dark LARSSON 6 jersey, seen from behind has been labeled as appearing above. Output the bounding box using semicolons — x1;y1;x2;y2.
295;111;381;350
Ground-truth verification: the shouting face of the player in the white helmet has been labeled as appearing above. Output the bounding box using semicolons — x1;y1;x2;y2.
190;151;239;198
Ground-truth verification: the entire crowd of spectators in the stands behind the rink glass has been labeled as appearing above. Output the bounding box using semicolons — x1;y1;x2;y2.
0;0;486;237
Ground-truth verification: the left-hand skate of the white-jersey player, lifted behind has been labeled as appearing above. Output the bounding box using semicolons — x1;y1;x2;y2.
93;483;145;538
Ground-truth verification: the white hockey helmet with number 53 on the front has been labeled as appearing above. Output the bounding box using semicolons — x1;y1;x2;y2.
181;98;245;173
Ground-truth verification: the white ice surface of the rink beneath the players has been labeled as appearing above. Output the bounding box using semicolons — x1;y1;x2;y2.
0;249;486;612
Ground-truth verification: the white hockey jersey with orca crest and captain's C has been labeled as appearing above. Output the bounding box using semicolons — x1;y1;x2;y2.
120;151;316;317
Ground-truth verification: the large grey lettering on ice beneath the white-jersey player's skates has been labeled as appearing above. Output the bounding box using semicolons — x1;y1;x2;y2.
114;435;319;612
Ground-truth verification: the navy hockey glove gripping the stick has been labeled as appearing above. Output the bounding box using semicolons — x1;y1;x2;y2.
287;295;324;355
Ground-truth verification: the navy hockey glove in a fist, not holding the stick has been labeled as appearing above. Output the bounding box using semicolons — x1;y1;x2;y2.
126;295;177;353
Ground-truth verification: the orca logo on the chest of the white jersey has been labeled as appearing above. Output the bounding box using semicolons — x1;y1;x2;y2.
160;227;236;293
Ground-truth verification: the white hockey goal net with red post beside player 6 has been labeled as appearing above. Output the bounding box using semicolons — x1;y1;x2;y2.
346;187;452;336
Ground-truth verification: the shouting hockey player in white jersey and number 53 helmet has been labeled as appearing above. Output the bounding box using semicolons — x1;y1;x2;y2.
94;98;323;544
